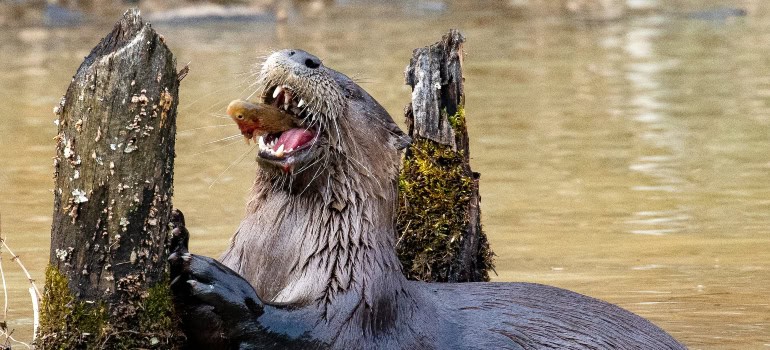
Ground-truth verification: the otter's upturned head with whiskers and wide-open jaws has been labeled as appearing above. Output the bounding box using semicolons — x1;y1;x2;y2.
250;50;409;196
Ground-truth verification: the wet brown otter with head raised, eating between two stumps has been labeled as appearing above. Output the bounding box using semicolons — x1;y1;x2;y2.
169;50;685;349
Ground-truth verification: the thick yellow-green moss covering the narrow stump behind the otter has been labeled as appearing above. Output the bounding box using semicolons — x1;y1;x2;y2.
397;136;492;281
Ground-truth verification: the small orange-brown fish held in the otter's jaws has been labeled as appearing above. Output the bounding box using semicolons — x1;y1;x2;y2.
227;100;295;143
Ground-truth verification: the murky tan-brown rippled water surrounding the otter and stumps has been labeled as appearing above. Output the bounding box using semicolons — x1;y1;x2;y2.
0;1;770;349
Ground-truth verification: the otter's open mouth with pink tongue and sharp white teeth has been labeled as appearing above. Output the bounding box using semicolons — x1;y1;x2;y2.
258;85;319;163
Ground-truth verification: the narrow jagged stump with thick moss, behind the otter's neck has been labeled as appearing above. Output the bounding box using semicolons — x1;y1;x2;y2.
397;30;493;282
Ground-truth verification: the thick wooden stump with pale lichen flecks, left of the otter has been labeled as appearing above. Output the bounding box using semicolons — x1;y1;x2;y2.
37;10;185;349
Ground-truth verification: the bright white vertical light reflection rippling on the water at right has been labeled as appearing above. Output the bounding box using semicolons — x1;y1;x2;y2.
624;20;692;236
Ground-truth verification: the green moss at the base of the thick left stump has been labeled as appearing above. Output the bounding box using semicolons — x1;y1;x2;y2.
36;266;183;350
